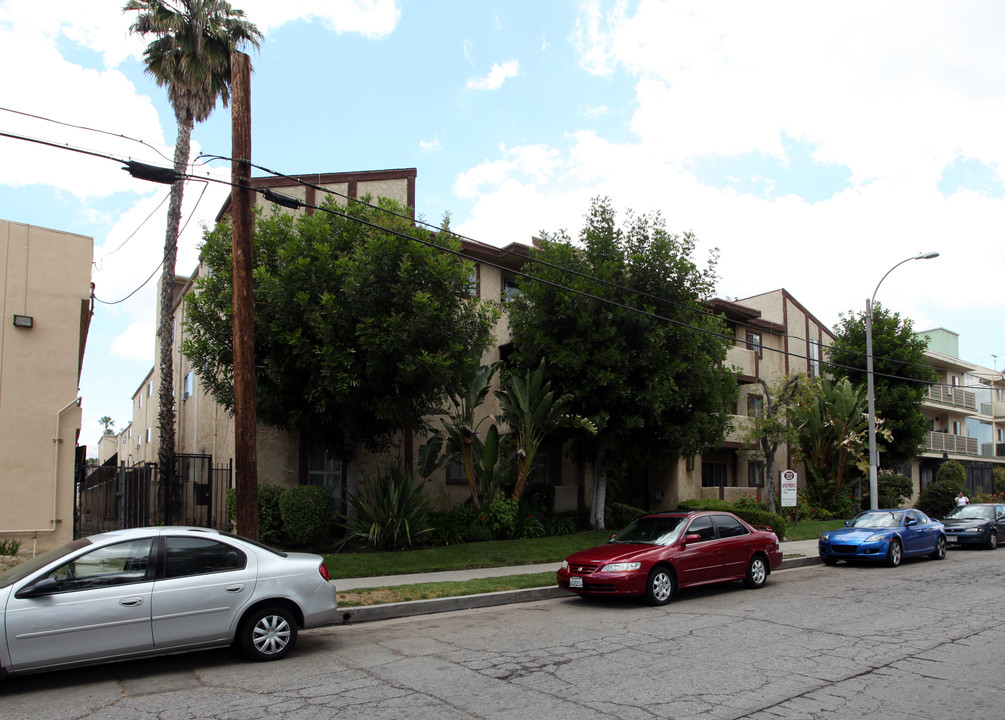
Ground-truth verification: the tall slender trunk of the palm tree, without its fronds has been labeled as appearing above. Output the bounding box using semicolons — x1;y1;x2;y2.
157;109;194;522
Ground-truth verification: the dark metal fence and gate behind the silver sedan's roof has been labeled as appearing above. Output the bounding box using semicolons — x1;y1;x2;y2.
73;455;233;537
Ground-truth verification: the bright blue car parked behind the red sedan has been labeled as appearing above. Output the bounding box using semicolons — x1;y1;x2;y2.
819;508;947;567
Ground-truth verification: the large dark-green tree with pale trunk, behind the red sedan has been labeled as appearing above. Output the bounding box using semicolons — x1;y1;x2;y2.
510;198;737;528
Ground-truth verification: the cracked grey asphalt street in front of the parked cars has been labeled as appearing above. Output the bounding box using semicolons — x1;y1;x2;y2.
0;550;1005;720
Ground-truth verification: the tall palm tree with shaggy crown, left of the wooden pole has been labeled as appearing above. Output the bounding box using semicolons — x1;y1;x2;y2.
123;0;262;506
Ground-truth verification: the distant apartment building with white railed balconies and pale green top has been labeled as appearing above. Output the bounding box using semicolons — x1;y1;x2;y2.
912;328;1005;493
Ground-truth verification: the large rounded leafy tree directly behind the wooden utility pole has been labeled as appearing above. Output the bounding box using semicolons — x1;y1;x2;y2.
182;199;498;453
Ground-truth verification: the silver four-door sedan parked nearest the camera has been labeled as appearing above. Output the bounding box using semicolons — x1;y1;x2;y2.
0;527;338;677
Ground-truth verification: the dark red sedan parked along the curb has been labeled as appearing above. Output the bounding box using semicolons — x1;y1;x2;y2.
558;512;782;605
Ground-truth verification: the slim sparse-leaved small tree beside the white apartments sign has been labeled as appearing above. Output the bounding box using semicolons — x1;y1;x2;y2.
742;374;809;513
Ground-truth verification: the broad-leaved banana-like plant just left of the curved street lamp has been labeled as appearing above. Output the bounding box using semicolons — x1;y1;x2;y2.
789;378;888;517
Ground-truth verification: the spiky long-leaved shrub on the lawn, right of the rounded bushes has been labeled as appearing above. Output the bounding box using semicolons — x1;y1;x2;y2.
344;464;432;550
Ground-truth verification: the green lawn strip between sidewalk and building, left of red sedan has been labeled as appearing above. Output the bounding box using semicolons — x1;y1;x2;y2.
325;530;611;578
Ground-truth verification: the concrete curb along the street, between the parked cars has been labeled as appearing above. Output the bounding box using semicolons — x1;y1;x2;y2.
336;556;820;624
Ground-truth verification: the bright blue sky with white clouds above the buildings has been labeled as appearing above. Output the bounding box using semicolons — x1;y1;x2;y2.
0;0;1005;456
